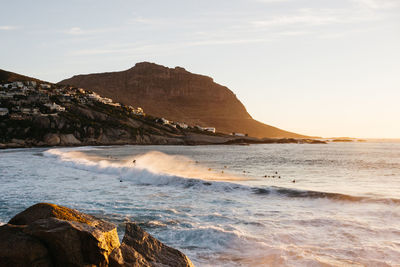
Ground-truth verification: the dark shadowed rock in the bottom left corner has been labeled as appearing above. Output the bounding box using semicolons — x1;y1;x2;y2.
0;224;53;267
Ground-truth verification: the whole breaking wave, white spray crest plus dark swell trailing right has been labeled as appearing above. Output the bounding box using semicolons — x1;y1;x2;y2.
43;147;400;204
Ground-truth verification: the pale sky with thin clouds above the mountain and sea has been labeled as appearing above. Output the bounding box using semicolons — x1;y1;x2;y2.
0;0;400;138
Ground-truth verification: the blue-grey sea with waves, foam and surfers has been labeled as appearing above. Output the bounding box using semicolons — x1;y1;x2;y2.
0;143;400;266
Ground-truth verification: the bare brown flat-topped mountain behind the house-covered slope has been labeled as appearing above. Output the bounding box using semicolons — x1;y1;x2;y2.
60;62;306;138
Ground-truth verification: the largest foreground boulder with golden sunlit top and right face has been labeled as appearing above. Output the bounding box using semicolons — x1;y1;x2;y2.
9;203;120;266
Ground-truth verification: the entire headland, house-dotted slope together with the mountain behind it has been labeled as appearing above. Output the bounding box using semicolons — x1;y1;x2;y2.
0;63;322;148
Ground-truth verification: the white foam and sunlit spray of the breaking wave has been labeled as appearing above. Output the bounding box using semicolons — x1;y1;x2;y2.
43;148;250;189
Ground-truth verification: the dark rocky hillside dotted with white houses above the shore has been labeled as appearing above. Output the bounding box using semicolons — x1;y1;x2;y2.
0;71;316;148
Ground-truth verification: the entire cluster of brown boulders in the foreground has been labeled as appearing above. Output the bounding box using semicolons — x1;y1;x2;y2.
0;203;193;266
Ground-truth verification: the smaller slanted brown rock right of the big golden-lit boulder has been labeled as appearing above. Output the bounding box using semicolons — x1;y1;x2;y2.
122;223;194;267
